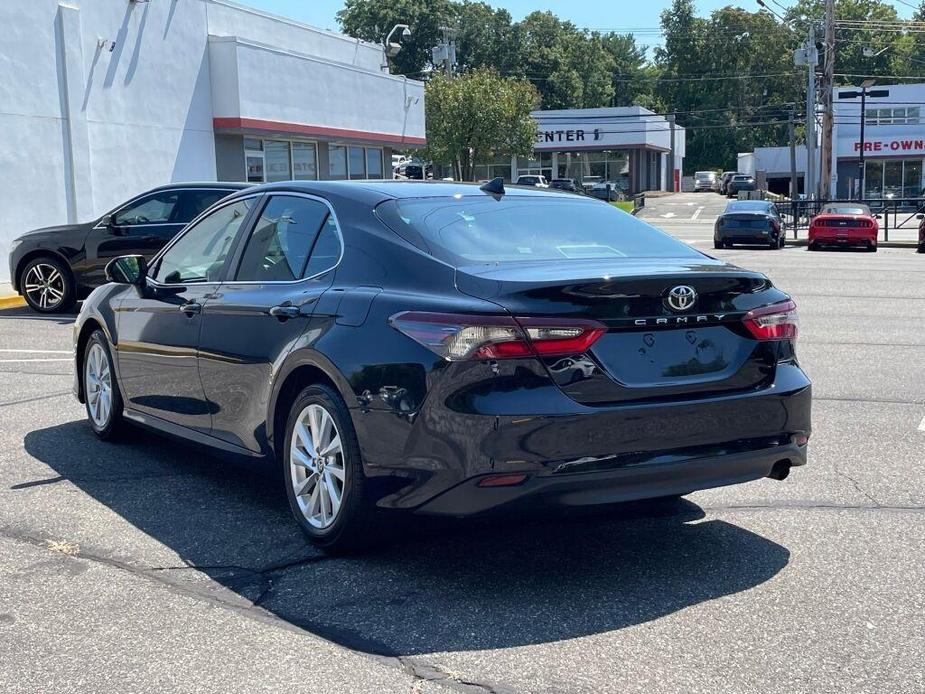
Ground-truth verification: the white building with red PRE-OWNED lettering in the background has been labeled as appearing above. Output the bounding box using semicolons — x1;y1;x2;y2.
739;84;925;199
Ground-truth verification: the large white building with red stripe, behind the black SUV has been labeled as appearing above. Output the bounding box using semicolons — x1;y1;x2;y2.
0;0;425;282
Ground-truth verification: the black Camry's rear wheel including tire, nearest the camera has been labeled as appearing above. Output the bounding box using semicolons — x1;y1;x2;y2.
281;385;373;552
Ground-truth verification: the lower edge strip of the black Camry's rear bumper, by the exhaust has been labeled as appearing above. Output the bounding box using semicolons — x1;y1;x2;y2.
417;442;806;516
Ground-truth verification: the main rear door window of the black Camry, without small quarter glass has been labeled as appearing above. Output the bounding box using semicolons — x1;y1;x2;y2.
235;195;328;282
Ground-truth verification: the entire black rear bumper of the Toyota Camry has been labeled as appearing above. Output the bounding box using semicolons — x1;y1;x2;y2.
354;363;812;516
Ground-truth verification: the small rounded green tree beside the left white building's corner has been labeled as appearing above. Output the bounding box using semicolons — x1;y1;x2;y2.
425;68;539;181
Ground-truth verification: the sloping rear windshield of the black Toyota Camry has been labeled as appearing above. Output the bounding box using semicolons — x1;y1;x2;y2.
376;195;702;267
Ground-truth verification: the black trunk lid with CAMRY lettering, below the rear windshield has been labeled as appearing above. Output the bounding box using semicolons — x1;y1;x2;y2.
457;256;787;404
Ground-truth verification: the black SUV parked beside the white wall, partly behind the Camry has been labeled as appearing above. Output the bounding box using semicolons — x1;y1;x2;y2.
10;183;248;313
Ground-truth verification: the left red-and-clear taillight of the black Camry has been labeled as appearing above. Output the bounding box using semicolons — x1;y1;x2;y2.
389;311;607;361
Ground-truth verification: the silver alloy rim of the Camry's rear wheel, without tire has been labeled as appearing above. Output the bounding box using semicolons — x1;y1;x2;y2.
289;404;346;530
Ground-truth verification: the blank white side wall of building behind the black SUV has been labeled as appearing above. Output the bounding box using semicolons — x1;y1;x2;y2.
0;0;215;281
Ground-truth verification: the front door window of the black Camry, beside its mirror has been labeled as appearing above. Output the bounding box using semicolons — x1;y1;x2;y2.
153;198;255;284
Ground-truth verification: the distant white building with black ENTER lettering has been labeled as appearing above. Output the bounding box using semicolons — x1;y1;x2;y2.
476;106;685;193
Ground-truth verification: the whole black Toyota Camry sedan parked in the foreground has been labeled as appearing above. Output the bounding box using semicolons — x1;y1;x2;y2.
74;179;810;549
